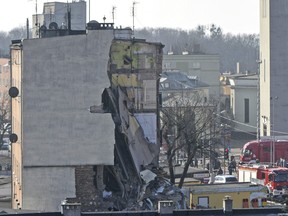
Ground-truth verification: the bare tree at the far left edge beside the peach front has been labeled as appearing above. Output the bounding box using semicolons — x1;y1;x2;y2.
0;93;11;148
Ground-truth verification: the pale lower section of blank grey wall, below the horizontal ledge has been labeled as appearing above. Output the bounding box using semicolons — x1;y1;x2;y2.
22;167;76;212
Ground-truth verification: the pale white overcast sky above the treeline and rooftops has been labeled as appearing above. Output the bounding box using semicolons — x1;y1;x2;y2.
0;0;259;34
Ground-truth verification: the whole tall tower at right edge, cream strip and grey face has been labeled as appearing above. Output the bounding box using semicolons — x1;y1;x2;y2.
259;0;288;136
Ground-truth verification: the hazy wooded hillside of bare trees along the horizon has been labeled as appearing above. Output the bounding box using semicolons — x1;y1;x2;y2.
0;24;259;72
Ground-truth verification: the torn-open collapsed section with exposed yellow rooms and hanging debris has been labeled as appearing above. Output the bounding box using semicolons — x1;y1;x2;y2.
90;39;177;210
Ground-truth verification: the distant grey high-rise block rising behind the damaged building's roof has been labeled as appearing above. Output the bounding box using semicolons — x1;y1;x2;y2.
32;0;86;38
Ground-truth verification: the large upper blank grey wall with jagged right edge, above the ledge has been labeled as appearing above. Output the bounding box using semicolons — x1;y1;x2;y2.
21;30;114;165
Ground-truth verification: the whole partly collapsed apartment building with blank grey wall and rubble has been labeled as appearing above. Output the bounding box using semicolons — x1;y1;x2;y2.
9;18;183;211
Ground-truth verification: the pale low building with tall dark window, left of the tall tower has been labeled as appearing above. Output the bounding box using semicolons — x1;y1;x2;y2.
220;73;258;136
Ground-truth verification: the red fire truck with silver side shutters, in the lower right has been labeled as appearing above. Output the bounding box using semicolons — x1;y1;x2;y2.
238;163;288;197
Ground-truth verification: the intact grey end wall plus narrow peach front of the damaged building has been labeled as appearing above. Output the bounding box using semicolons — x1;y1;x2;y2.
11;30;115;211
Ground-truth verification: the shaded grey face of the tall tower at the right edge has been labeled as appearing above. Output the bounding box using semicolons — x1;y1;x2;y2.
270;0;288;135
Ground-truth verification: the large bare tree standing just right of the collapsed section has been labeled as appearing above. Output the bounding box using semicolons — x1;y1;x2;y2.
161;92;219;188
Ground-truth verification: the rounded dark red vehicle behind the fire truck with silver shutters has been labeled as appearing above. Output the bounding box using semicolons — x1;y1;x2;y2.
240;138;288;166
